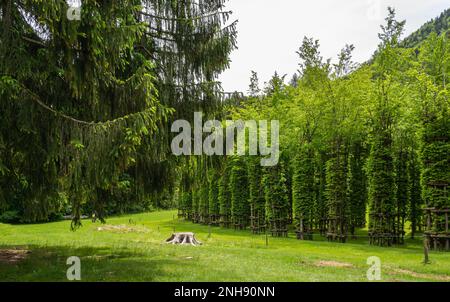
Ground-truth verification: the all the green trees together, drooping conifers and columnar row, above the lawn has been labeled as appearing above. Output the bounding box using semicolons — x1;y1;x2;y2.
0;0;450;284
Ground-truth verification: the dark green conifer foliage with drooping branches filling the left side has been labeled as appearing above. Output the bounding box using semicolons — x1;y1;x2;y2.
0;0;236;226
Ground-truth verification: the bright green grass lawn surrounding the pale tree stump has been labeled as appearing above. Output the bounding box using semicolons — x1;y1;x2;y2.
0;211;450;281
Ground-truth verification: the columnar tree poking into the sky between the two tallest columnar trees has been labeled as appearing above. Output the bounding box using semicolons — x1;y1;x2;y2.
326;45;359;242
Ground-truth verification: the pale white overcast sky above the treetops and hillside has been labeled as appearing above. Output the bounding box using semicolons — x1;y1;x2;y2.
219;0;450;93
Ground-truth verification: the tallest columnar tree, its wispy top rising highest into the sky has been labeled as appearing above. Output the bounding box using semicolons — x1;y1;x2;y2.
367;8;405;246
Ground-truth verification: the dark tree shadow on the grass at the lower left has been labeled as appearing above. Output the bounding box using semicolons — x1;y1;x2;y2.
0;246;186;282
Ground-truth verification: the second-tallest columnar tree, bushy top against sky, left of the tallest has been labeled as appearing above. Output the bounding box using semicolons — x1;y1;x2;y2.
291;37;329;239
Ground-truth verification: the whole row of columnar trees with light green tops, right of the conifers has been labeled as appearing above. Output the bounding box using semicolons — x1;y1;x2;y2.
180;9;450;246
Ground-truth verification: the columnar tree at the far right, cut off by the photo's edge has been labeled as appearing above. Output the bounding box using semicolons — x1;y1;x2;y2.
416;34;450;250
